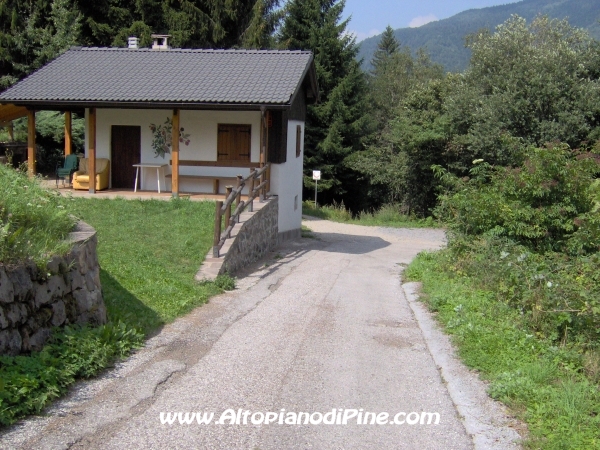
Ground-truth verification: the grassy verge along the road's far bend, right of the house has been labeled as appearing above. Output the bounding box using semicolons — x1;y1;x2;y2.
302;201;442;228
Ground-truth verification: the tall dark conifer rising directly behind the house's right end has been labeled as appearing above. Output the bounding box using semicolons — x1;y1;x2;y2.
279;0;366;211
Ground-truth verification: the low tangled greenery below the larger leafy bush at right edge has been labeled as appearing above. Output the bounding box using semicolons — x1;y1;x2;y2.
440;237;600;347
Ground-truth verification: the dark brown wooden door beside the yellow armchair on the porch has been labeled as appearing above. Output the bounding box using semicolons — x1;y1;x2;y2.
111;125;142;189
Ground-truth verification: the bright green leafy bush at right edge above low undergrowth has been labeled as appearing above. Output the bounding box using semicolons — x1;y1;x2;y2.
434;144;600;254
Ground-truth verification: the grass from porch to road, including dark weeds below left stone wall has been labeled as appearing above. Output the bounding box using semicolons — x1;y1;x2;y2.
0;194;233;425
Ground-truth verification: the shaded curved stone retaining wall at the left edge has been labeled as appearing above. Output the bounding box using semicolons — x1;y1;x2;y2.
0;222;106;355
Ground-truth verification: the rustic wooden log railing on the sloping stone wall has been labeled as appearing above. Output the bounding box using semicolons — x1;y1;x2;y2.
213;164;269;258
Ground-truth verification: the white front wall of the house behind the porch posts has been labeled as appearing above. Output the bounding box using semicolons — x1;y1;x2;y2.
85;109;260;192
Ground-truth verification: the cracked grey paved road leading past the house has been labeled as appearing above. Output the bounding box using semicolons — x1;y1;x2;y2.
0;220;520;450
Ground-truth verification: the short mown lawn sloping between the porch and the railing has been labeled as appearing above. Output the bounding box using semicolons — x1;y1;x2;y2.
65;198;222;333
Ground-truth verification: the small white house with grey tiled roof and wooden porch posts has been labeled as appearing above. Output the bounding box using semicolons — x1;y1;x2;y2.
0;36;319;243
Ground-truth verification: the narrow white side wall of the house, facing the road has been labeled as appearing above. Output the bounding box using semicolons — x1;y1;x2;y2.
271;120;304;233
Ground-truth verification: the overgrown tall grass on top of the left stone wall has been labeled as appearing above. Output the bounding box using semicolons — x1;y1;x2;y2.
0;164;75;265
